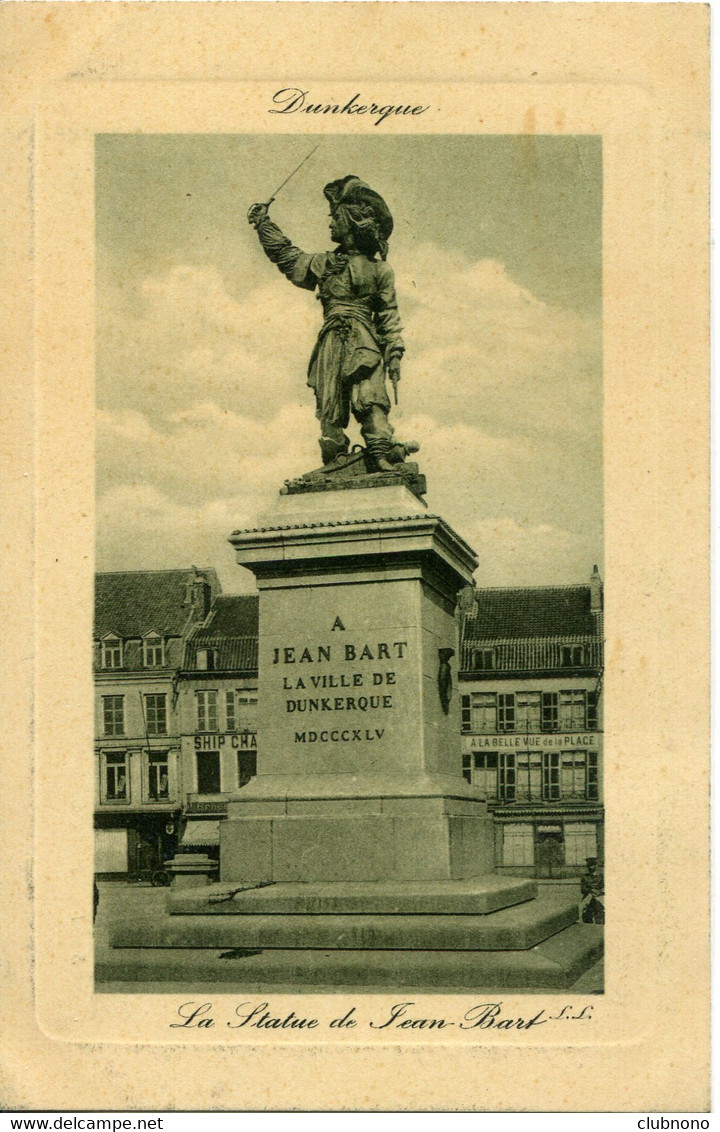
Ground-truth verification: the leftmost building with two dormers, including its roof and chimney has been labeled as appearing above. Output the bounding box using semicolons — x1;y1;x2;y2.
93;567;220;876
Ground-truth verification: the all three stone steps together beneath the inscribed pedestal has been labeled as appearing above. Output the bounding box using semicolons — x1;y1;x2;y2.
97;876;602;991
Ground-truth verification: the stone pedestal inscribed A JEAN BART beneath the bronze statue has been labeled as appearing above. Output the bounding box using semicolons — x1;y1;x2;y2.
221;483;492;884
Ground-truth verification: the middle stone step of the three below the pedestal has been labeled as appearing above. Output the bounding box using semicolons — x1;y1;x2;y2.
110;897;577;951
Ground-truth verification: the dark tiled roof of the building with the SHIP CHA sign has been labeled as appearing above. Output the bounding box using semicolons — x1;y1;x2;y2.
183;594;259;672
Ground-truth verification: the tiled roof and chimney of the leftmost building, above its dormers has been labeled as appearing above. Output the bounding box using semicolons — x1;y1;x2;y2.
95;566;220;640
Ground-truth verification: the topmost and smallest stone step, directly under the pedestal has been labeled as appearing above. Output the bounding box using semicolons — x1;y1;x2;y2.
168;875;538;916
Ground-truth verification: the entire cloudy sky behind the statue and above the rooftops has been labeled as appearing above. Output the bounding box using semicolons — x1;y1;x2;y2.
96;134;602;592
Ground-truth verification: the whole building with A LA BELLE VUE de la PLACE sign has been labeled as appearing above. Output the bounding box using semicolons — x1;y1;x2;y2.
460;567;603;877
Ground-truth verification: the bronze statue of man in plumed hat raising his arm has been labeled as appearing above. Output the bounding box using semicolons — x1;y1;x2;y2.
248;177;406;471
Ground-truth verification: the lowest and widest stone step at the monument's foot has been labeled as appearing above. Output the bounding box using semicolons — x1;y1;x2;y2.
95;924;602;1002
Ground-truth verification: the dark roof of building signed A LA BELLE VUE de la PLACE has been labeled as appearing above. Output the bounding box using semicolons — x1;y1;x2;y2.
463;585;600;643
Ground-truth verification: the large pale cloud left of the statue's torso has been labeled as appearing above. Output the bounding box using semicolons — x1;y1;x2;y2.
97;264;317;419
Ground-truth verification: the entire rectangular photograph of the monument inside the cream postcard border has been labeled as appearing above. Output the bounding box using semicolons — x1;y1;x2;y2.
88;134;605;994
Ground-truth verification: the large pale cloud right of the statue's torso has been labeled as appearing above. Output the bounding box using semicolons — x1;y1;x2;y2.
396;245;600;439
